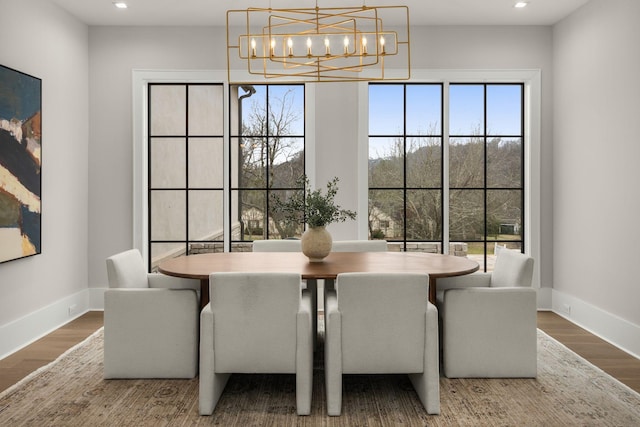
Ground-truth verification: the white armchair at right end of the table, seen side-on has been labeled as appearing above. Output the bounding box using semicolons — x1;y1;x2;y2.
437;249;537;378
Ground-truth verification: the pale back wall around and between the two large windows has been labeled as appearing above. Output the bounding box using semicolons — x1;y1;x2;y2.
89;27;552;288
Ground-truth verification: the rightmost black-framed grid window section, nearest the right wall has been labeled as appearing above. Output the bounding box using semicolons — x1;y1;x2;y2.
449;83;525;270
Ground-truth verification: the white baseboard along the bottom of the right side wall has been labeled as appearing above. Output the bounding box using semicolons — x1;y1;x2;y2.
552;289;640;359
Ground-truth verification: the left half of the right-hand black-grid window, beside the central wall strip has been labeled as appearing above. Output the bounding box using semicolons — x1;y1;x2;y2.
368;83;443;252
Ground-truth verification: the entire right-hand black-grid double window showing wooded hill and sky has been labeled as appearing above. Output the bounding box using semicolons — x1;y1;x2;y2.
368;83;524;269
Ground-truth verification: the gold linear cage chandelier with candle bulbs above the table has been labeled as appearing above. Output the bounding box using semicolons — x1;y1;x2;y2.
227;3;411;83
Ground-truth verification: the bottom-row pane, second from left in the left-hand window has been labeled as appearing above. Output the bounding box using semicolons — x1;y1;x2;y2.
189;190;224;240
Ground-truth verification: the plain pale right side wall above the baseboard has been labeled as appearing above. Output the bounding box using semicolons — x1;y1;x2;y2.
553;0;640;334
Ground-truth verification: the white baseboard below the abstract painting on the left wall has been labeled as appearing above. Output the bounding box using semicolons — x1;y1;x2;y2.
0;289;90;359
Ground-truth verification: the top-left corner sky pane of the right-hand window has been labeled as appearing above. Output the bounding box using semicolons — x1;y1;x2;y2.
369;85;404;135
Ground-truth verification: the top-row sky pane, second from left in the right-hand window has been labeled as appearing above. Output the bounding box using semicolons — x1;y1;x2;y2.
407;84;442;135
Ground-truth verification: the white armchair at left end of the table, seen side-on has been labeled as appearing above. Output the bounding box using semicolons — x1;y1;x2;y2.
104;249;200;378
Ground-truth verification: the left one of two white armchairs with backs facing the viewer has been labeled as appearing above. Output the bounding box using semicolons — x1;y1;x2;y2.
199;273;313;415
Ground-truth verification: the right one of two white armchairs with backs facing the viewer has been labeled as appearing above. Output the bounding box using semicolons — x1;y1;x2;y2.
324;273;440;416
